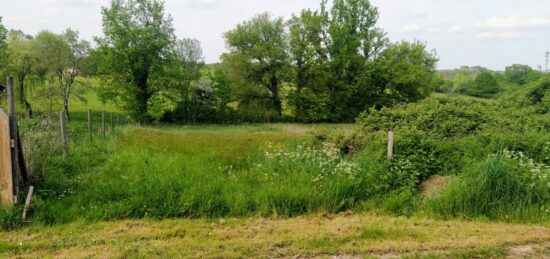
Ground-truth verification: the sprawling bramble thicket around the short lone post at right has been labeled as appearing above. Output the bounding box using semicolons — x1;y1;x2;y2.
358;89;550;199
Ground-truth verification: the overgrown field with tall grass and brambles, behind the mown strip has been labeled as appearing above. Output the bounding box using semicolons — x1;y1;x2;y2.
0;77;550;228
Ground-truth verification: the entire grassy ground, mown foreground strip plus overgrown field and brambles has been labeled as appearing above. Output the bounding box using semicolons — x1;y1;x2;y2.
0;75;550;258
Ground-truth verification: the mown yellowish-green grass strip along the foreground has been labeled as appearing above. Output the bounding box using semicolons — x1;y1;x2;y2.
0;214;550;258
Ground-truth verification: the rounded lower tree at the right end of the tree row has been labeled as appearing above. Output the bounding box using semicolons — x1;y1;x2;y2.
372;41;437;106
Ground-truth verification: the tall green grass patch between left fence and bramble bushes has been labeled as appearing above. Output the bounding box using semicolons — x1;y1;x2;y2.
27;128;380;224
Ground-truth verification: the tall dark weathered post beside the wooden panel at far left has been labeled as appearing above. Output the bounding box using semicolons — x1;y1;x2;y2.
7;76;19;203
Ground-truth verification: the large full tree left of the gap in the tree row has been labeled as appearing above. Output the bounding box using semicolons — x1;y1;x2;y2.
97;0;175;122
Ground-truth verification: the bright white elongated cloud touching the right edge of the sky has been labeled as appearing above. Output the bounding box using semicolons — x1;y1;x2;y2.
475;15;550;29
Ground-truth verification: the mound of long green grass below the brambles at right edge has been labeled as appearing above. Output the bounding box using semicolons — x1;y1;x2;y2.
432;153;550;221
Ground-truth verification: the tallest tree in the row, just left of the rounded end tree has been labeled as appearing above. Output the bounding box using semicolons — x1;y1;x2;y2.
322;0;387;121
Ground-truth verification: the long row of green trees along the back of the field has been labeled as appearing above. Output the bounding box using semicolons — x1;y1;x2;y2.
0;0;437;123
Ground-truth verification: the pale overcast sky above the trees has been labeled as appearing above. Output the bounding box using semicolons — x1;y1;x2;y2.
0;0;550;70
